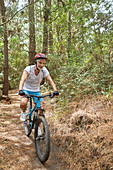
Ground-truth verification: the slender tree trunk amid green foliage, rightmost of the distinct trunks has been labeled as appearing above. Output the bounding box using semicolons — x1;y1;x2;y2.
67;11;71;58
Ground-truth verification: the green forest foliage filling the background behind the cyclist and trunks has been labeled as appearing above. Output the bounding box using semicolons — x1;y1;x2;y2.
0;0;113;102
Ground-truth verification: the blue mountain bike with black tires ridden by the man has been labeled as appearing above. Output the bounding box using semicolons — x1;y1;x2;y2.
24;94;54;163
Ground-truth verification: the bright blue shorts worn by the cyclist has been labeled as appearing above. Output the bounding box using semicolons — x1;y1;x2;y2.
23;90;44;108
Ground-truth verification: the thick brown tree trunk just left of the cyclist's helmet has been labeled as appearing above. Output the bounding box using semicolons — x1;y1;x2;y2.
28;0;36;65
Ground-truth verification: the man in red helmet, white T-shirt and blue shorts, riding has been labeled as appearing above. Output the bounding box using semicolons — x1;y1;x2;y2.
19;53;59;121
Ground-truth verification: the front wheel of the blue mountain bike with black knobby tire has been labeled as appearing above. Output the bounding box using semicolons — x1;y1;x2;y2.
34;116;50;163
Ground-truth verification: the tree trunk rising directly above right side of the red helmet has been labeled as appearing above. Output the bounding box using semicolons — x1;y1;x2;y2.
42;0;48;54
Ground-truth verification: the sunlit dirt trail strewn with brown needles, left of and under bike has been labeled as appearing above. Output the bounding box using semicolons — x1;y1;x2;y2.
0;91;62;170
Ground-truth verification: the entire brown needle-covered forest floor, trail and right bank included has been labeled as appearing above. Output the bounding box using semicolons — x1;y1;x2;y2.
0;90;113;170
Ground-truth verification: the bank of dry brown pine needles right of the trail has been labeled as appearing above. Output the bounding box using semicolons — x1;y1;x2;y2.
46;96;113;170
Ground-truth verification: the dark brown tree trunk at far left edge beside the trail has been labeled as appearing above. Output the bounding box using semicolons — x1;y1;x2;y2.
0;0;9;95
